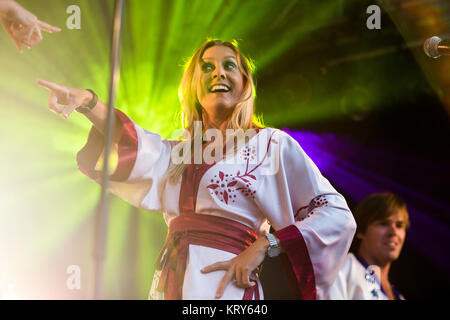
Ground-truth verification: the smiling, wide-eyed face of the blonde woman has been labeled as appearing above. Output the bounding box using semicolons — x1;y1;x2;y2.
197;46;244;114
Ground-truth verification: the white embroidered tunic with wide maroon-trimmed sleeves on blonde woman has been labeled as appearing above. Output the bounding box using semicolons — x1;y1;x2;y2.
78;110;356;299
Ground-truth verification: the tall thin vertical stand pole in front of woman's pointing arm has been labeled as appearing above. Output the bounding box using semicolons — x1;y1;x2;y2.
93;0;125;300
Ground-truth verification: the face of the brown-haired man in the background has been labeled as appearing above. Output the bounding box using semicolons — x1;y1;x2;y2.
358;209;407;262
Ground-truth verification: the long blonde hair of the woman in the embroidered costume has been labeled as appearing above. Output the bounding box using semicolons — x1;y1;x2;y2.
162;40;262;184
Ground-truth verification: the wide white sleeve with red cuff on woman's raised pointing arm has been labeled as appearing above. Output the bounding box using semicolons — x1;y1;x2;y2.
77;109;172;211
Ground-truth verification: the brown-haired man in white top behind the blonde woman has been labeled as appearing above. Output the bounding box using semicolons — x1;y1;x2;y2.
329;192;409;300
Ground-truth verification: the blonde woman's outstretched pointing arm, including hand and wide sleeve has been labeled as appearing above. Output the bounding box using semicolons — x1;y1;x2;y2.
37;78;177;212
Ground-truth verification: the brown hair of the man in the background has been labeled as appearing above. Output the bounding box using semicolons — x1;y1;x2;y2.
350;192;409;252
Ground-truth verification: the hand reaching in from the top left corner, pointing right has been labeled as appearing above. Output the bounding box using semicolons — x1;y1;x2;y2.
0;0;61;52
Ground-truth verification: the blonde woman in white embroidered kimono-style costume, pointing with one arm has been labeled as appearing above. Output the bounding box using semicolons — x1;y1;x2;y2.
38;40;356;299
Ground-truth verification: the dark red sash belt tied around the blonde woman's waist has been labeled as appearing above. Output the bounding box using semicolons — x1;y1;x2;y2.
157;213;259;300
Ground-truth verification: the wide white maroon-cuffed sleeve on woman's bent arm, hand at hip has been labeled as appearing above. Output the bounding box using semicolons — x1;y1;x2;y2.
256;130;356;299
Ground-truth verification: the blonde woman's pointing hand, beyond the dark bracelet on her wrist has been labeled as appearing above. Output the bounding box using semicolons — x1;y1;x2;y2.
37;79;92;119
